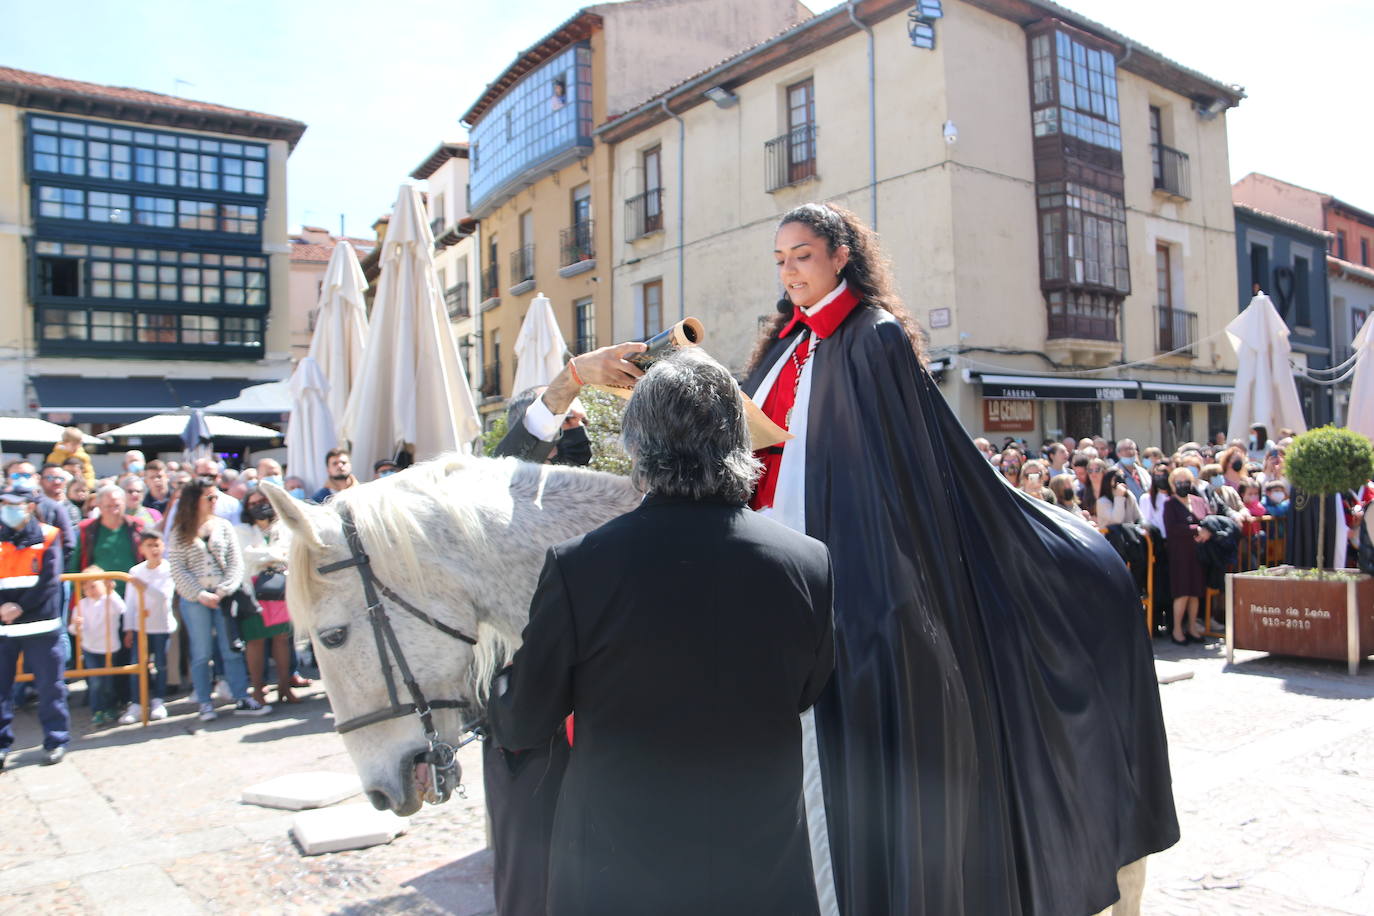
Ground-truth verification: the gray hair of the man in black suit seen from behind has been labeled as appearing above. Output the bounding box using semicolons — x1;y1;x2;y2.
621;347;763;504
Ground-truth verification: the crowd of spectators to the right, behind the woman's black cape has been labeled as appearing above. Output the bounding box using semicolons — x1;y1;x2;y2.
974;426;1374;644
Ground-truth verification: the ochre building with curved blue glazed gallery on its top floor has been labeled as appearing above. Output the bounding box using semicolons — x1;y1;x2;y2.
463;0;809;411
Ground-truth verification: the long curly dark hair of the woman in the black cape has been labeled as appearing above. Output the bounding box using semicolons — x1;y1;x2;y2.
746;203;925;371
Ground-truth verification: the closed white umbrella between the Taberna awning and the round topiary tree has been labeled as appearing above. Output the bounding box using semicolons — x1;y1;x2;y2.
1226;293;1307;439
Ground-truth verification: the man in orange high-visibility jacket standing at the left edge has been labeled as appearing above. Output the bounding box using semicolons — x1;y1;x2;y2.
0;483;70;768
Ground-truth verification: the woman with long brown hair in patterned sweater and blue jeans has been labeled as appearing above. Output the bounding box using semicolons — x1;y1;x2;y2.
168;478;272;722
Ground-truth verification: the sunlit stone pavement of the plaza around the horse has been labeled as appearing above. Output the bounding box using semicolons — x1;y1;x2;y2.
0;641;1374;916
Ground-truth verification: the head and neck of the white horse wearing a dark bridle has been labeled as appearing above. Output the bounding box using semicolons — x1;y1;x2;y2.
262;455;640;814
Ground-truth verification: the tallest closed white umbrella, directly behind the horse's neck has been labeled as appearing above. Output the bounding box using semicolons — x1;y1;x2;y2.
339;184;481;468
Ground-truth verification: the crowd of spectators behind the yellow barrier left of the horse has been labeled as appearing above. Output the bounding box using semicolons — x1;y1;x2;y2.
0;428;396;747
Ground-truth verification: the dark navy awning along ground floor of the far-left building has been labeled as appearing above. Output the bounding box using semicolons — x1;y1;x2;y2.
29;375;260;424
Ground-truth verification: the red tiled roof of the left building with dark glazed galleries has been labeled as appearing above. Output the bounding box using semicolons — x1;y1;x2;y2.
0;66;305;147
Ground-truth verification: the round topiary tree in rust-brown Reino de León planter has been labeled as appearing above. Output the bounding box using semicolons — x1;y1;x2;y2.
1226;426;1374;674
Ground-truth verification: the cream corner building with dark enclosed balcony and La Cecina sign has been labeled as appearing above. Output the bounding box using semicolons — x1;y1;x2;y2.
598;0;1243;445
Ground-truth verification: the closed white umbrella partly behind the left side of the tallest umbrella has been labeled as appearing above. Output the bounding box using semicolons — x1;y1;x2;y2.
308;239;367;426
